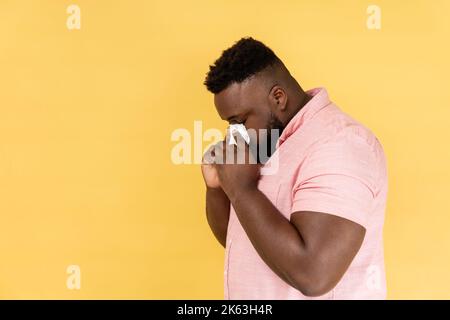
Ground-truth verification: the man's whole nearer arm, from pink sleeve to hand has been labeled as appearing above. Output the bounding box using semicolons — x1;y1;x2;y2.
214;131;376;296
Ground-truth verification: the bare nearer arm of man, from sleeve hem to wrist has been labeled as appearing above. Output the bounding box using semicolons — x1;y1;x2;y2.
230;187;365;296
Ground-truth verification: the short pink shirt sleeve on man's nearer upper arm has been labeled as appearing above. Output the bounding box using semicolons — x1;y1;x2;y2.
292;130;378;228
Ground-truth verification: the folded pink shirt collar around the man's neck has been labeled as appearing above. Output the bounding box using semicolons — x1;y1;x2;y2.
276;88;330;148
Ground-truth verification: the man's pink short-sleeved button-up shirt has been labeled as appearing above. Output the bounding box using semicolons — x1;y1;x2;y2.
224;88;387;299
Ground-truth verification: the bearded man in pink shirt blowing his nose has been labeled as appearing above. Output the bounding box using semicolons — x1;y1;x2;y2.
202;38;387;299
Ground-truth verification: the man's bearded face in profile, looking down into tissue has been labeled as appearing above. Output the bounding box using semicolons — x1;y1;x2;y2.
214;79;284;162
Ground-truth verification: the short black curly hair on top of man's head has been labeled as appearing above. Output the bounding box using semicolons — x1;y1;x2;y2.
204;37;281;94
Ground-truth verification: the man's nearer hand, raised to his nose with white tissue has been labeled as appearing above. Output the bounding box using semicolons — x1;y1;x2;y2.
214;141;260;202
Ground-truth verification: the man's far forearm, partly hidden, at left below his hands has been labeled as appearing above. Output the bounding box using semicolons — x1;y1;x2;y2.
206;187;230;247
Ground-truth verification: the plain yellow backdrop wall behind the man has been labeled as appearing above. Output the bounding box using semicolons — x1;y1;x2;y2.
0;0;450;299
